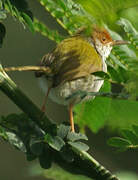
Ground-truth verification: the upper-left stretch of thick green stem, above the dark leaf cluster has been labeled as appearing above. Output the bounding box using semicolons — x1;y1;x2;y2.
0;67;51;129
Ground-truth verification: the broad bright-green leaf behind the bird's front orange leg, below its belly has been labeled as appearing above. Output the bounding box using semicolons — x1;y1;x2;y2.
74;82;110;132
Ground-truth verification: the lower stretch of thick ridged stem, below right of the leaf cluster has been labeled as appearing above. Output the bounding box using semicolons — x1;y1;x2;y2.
56;148;119;180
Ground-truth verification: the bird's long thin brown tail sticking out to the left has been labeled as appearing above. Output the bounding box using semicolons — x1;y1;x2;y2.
3;66;51;75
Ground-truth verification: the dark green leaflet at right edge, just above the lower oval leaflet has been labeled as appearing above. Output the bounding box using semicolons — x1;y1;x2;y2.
121;129;138;145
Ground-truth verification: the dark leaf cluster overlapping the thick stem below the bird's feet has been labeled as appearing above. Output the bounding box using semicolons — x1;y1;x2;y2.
0;114;88;169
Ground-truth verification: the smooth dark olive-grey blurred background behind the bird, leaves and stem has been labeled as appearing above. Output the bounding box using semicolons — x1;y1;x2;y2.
0;0;138;180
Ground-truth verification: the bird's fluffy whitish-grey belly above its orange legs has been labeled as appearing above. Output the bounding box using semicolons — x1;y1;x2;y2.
40;75;104;105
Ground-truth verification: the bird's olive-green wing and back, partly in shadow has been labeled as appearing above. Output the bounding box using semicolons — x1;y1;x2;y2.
52;36;102;86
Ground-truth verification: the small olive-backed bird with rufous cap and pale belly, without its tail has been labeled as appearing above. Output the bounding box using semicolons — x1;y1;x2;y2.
35;27;127;132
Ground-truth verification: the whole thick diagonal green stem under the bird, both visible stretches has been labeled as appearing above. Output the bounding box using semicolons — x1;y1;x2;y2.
0;67;119;180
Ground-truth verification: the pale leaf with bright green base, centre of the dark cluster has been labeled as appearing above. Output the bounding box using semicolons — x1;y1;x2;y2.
45;134;65;151
